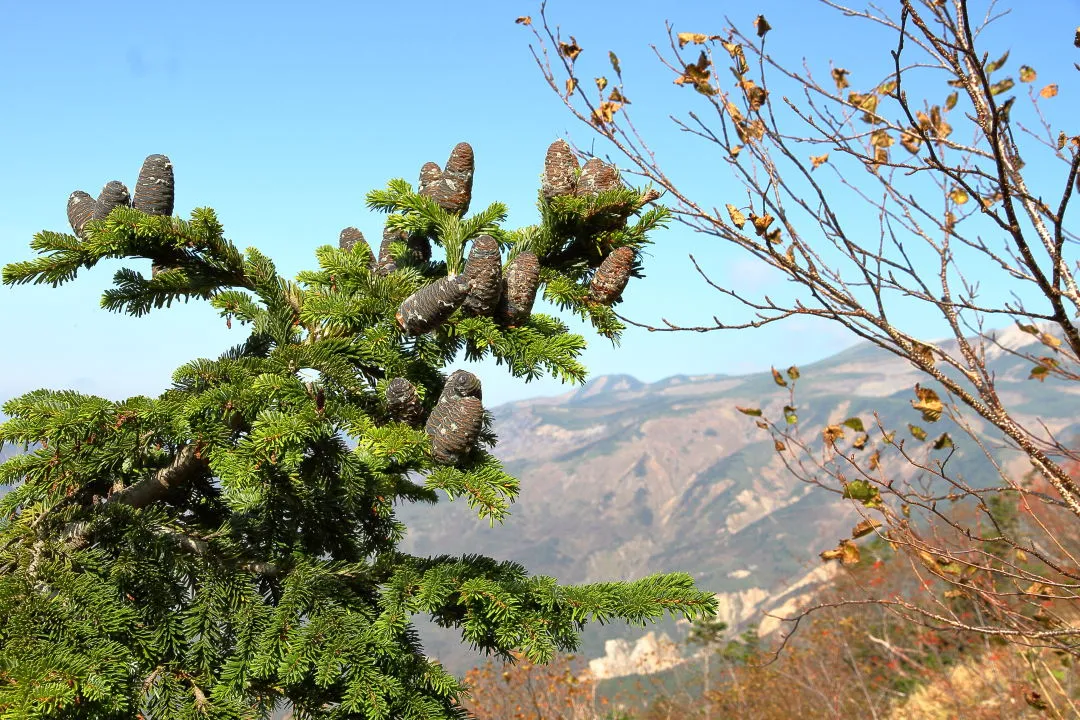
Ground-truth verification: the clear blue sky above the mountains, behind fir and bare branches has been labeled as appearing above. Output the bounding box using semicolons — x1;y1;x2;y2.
0;0;1080;405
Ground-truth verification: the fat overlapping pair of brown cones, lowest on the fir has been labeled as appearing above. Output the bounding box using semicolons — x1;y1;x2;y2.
424;370;484;464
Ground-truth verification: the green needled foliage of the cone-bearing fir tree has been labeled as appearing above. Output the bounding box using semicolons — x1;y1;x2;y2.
0;146;715;720
